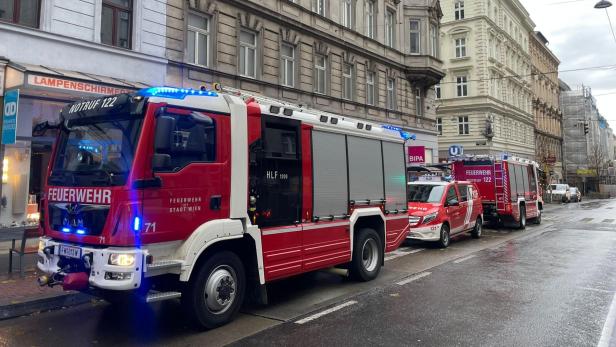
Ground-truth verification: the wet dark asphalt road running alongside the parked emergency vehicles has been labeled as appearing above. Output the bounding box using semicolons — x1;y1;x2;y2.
0;200;616;346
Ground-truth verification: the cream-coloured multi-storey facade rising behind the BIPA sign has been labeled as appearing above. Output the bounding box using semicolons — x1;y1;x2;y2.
435;0;535;161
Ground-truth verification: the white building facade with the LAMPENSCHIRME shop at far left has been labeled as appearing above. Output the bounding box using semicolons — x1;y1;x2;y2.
0;0;168;226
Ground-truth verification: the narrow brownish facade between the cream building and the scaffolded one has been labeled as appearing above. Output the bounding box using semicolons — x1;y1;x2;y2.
529;31;564;183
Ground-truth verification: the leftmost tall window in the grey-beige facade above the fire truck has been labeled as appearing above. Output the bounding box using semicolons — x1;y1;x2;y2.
187;13;210;66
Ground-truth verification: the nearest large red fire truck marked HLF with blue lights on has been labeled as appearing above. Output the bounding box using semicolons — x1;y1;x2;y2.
38;88;409;328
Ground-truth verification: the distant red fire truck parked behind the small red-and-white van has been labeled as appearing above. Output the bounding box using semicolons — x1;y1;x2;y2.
452;156;543;229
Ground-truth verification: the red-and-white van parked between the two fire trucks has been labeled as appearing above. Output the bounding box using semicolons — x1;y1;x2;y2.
407;181;483;248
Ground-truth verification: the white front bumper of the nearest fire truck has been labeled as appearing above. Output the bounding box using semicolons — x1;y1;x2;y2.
37;237;147;290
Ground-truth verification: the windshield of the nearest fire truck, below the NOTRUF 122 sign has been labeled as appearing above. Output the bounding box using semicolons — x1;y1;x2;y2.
48;114;142;187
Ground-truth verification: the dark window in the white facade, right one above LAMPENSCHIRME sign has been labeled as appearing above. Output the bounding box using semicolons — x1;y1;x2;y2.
101;0;133;49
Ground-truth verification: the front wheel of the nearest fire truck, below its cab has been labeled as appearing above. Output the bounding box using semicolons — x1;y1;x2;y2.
182;251;246;329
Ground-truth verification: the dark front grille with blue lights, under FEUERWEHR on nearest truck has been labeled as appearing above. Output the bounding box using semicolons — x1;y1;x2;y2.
49;203;109;236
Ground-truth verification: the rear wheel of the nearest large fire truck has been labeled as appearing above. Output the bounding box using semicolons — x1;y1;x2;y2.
349;228;383;282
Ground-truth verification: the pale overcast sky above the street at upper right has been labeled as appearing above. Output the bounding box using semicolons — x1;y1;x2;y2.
520;0;616;129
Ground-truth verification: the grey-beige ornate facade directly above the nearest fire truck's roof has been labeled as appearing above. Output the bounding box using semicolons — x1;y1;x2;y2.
166;0;443;167
